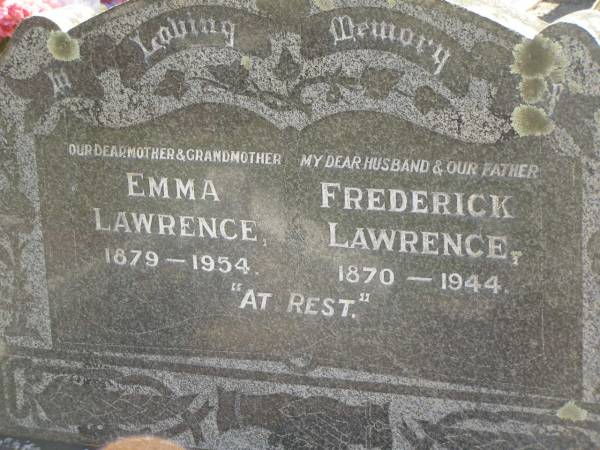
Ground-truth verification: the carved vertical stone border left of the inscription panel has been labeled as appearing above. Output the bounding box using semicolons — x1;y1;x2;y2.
0;79;51;348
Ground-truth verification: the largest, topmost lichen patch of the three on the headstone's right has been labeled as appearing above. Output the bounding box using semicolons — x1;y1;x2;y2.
512;36;562;78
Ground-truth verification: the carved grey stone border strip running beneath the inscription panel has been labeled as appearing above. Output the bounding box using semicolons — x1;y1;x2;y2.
5;358;600;450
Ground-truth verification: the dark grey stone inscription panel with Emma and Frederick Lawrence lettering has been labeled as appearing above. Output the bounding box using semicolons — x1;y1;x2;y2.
39;107;582;392
